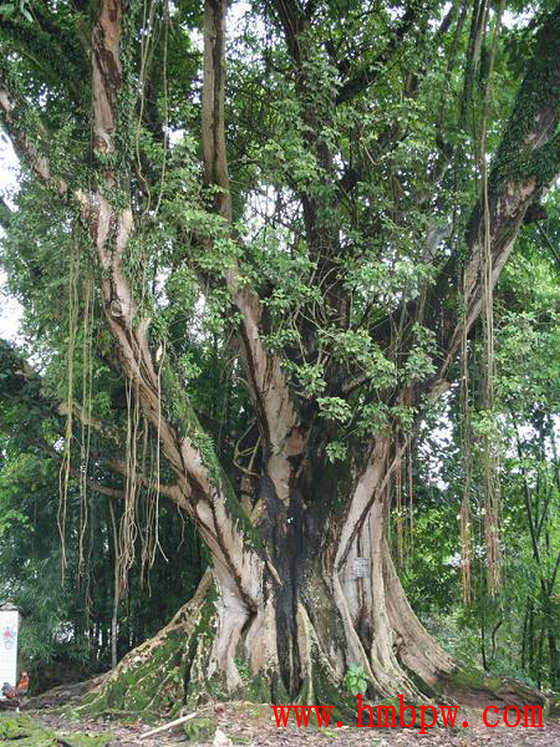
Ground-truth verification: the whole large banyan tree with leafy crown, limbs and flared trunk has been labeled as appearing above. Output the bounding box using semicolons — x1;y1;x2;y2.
0;0;560;703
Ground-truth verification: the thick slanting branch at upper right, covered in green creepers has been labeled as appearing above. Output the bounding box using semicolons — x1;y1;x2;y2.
438;6;560;375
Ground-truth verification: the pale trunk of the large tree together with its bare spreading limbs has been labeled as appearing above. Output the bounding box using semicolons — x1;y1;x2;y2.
74;0;559;716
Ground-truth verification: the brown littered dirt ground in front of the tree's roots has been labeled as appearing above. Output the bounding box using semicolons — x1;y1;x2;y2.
0;703;560;747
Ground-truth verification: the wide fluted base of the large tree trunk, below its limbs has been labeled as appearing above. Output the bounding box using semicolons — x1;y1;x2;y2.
81;440;454;712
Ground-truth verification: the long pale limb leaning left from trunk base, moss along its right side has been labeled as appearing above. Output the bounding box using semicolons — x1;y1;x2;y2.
82;0;270;648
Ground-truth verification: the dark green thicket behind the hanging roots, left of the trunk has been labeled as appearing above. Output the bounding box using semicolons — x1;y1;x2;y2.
0;343;206;688
